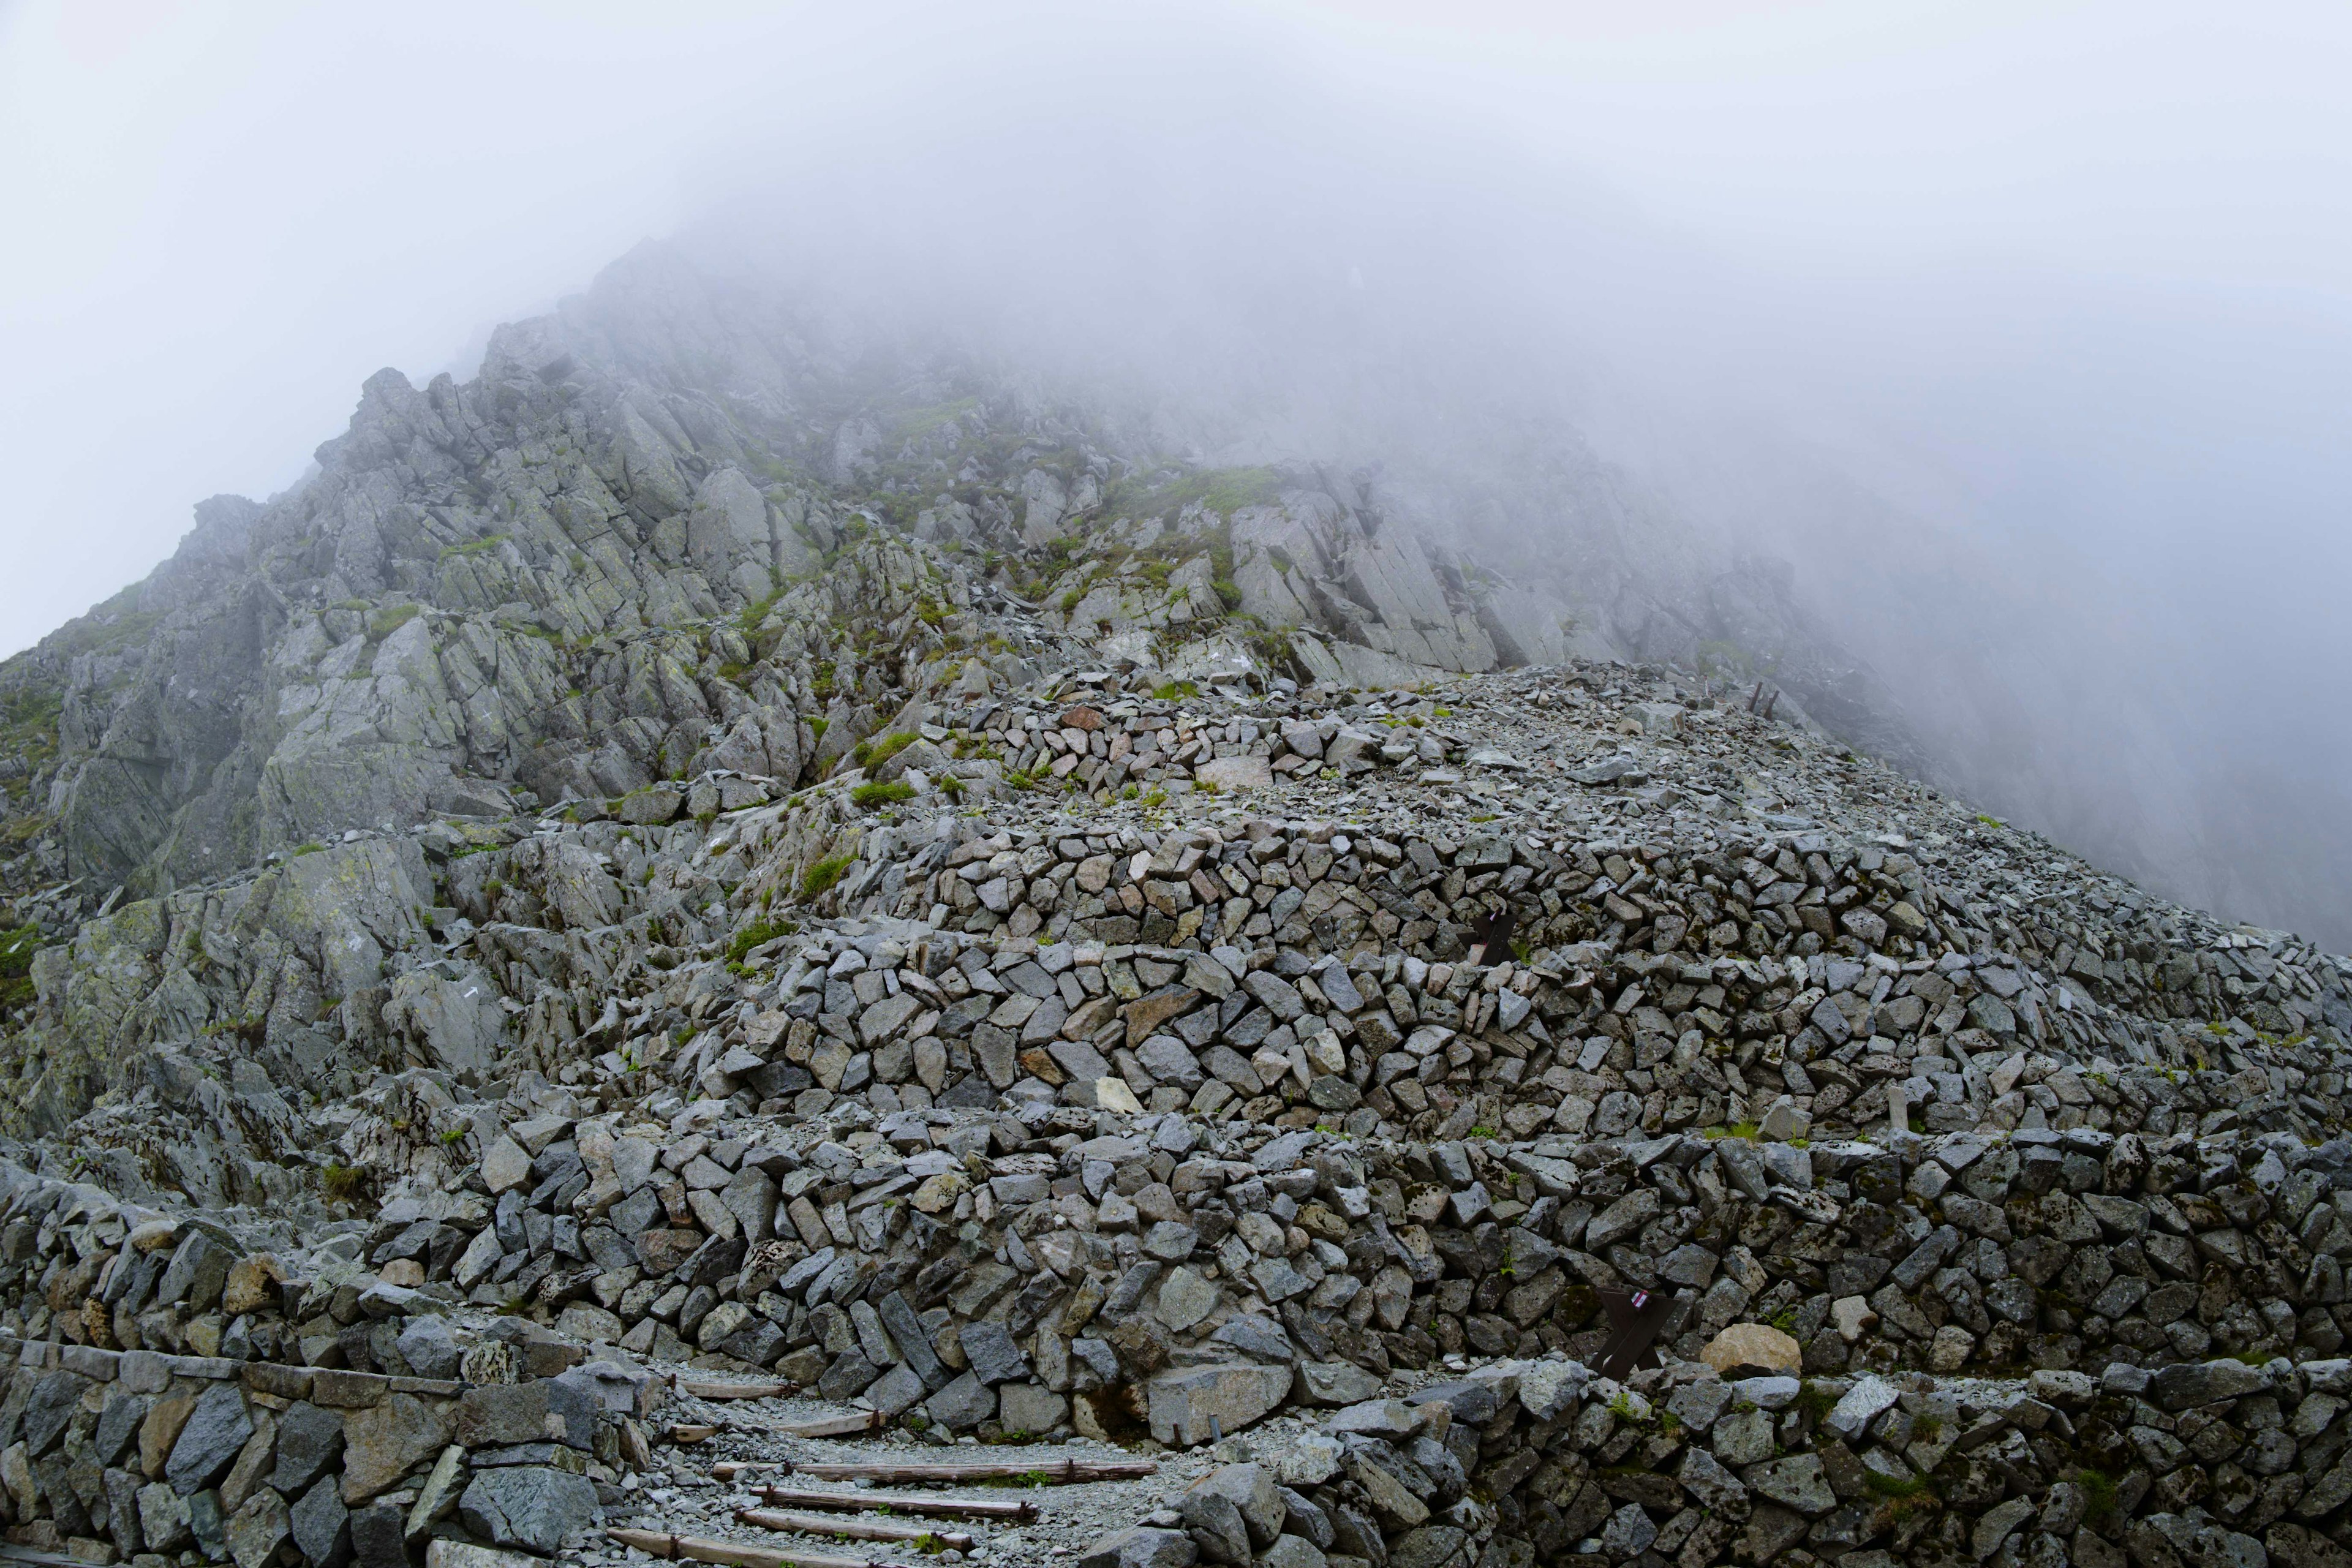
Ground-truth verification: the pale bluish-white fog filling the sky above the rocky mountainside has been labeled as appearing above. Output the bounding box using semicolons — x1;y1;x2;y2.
0;0;2352;948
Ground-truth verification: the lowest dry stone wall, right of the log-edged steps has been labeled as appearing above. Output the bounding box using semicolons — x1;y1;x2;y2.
1080;1359;2352;1568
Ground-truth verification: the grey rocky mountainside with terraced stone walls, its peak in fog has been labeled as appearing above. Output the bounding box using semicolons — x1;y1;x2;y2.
0;247;2352;1568
